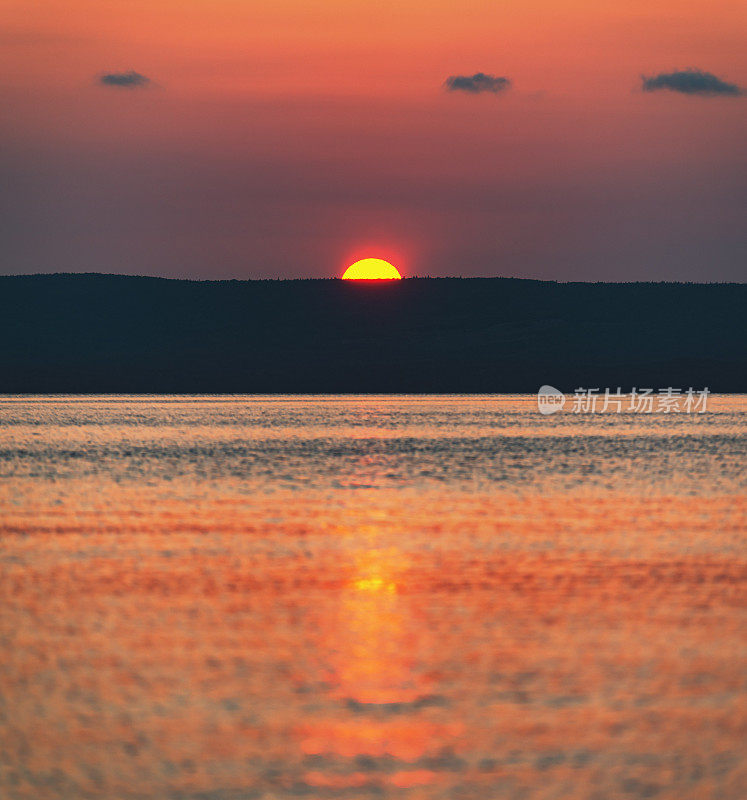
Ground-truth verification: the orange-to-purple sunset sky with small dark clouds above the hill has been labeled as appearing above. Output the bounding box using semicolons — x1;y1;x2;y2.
0;0;747;280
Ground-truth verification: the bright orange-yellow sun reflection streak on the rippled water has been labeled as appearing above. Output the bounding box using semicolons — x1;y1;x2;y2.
294;544;463;789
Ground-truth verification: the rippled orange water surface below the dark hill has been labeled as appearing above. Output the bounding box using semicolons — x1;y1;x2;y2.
0;396;747;800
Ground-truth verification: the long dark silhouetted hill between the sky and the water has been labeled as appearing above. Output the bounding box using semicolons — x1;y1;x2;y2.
0;274;747;393
